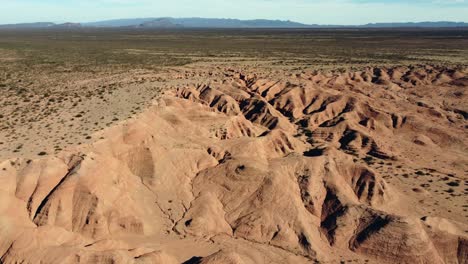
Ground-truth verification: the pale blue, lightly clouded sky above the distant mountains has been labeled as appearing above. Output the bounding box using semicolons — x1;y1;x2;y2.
0;0;468;25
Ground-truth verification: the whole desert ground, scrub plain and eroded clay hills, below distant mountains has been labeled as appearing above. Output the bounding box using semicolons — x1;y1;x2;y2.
0;29;468;264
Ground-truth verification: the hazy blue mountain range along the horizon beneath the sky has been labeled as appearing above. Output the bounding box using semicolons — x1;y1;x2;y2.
0;17;468;29
